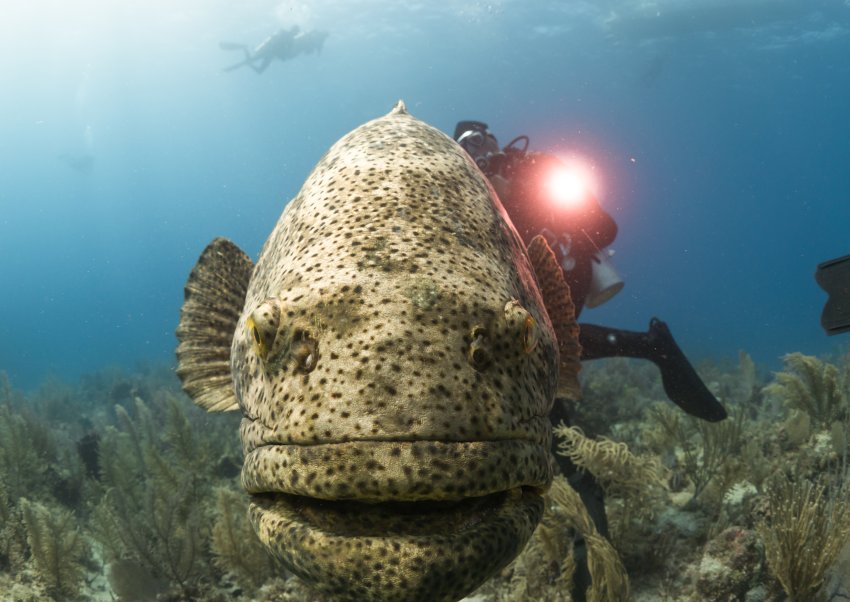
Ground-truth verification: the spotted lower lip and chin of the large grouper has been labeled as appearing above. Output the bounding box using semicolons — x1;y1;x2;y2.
250;487;543;602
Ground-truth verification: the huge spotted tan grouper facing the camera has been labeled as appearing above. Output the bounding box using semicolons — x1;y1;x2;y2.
177;102;579;602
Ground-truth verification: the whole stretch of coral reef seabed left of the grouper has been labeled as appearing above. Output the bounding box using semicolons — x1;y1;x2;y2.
0;370;280;600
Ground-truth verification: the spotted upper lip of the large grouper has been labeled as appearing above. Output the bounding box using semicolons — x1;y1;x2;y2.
242;439;552;502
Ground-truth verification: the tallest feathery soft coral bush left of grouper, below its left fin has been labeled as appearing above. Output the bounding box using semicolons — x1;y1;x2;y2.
93;398;212;596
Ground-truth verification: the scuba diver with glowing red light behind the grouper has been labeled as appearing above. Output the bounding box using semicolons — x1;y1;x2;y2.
454;121;726;600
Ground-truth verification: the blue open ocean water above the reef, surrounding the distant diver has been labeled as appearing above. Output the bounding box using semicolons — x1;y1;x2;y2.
0;0;850;388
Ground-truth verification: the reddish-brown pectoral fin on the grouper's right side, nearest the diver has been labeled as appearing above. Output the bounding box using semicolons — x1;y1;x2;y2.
528;235;581;400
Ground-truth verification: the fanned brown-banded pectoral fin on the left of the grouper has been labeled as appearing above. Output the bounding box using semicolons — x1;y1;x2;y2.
177;238;254;412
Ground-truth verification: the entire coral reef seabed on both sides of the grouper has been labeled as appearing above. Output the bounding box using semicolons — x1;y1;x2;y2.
0;344;850;602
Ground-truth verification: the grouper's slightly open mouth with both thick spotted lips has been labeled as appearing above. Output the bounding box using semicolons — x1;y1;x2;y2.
243;440;551;601
